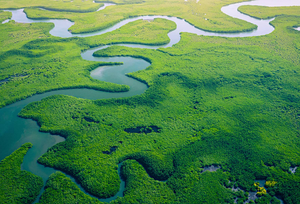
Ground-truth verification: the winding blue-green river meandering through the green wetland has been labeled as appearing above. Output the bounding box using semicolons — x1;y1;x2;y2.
0;0;300;202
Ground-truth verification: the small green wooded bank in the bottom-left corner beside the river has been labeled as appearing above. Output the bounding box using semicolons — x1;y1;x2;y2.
0;143;43;204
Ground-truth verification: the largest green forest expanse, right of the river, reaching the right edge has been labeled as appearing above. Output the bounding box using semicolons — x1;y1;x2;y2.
20;12;300;203
